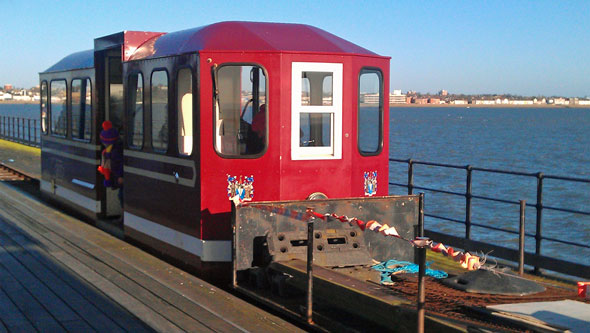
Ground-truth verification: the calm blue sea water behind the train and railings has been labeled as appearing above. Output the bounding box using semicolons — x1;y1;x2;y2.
0;104;590;260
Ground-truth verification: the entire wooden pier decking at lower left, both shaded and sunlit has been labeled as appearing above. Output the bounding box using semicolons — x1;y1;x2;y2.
0;175;300;332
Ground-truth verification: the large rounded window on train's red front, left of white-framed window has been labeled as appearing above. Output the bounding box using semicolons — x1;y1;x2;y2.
215;65;268;157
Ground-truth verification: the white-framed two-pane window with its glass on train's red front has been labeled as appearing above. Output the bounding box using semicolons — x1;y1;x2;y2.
291;62;342;160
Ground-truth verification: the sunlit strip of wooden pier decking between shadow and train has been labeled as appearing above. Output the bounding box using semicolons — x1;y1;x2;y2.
0;184;301;332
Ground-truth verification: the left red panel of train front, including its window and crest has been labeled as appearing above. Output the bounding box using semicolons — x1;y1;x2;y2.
200;52;282;240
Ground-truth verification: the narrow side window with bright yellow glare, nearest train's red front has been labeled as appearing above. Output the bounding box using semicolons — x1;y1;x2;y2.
176;68;193;155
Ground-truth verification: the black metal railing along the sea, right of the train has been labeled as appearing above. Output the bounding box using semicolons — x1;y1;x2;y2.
389;158;590;277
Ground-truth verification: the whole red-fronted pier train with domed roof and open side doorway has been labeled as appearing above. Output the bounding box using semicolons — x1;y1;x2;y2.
40;22;389;269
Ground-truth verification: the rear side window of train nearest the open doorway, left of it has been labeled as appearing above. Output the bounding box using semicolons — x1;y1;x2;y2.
72;79;92;141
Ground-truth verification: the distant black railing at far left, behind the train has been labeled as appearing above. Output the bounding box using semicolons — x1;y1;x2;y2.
0;116;41;147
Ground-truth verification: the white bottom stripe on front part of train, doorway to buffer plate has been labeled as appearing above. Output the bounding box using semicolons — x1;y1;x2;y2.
123;212;231;262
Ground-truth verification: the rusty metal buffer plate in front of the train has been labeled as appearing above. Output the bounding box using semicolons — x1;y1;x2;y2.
233;195;419;270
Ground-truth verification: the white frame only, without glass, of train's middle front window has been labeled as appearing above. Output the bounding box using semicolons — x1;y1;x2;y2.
291;62;343;160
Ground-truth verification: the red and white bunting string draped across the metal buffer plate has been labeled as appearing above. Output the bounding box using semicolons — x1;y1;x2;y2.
241;203;483;271
